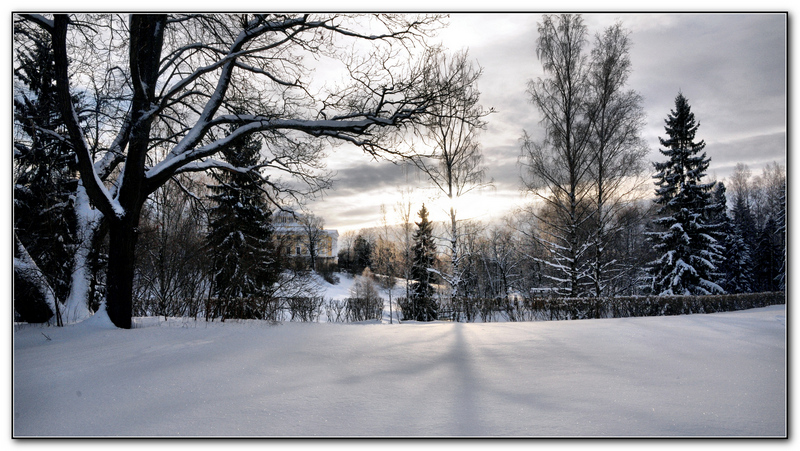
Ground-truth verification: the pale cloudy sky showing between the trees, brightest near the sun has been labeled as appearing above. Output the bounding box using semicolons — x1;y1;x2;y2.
309;12;787;233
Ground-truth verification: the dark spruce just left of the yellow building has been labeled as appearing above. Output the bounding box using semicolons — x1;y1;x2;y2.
207;132;280;319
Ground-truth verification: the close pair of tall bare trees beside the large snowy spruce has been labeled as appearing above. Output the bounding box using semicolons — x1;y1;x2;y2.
523;14;647;296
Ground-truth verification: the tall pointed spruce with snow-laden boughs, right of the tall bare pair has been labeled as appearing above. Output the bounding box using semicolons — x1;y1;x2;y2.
649;94;724;295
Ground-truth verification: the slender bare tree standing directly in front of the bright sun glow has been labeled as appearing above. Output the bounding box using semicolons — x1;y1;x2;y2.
416;50;491;298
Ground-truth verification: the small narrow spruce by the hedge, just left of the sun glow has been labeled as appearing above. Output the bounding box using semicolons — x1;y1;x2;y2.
406;204;439;321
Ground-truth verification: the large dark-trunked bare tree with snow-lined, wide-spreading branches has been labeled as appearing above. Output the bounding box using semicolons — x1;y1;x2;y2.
20;14;462;328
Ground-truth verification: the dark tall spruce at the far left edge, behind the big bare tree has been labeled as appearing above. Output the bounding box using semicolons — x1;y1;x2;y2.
14;24;79;322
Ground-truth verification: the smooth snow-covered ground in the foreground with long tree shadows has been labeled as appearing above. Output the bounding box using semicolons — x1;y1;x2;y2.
13;300;787;437
